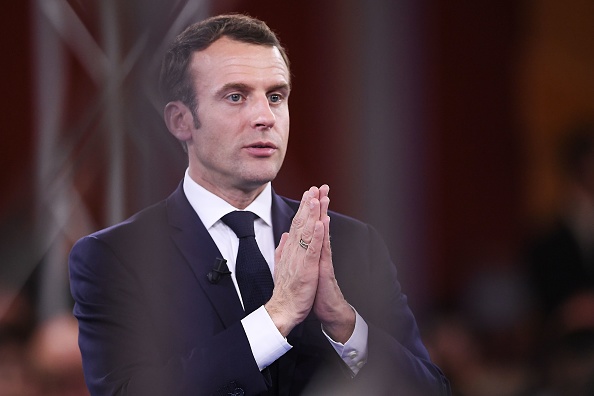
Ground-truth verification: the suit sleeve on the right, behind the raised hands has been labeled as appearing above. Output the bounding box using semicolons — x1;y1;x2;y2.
333;221;451;396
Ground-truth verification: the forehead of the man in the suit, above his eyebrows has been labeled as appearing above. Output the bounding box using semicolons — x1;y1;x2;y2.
190;37;290;90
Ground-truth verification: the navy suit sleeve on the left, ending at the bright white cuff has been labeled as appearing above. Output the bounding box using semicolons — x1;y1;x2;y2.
69;236;266;396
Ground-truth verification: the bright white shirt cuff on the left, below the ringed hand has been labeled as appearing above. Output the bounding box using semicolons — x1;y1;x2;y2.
241;306;292;371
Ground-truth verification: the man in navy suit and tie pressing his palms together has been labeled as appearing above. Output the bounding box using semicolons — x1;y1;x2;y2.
70;15;449;395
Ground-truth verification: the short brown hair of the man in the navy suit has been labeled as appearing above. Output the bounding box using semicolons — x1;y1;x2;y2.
159;14;289;116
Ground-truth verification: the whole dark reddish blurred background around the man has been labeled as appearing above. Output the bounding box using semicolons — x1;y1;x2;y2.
0;0;594;396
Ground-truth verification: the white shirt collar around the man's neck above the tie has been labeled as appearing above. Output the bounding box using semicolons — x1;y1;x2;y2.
183;169;272;229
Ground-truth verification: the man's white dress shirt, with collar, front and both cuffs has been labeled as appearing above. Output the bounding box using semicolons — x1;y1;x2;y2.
183;170;368;375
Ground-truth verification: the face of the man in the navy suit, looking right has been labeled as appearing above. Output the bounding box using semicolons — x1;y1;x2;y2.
187;37;290;198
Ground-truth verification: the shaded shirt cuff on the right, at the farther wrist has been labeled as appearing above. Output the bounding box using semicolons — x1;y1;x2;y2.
322;308;369;377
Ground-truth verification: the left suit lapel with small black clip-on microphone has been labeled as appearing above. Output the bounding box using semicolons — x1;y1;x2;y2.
167;184;245;327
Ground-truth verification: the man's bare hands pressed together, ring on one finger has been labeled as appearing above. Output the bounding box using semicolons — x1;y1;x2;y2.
265;185;355;343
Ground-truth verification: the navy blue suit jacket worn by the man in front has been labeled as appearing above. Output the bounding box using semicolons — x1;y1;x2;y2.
69;185;449;396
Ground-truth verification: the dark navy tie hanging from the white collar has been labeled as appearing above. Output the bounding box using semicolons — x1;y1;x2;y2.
221;211;274;314
